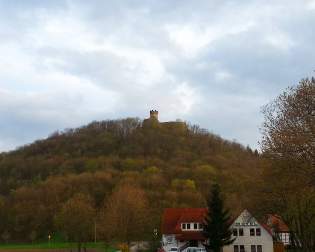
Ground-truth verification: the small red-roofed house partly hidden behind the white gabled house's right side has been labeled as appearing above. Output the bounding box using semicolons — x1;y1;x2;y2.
266;214;291;246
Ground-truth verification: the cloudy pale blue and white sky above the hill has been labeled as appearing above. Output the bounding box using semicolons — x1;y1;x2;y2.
0;0;315;152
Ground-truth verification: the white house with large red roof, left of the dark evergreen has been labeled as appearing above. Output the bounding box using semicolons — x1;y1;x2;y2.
161;208;207;252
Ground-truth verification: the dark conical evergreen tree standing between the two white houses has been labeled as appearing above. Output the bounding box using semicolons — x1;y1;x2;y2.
203;184;235;252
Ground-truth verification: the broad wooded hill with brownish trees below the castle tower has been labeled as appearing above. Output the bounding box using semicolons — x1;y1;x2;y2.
0;112;263;240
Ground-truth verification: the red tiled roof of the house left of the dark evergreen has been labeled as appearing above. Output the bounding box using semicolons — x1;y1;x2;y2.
161;208;207;234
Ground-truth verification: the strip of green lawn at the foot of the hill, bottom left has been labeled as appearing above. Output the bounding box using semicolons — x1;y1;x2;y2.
0;242;116;252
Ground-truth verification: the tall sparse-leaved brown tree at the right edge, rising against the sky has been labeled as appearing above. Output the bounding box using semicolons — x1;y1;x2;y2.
261;78;315;252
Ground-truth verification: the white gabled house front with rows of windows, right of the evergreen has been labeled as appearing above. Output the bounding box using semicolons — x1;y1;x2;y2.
223;210;273;252
